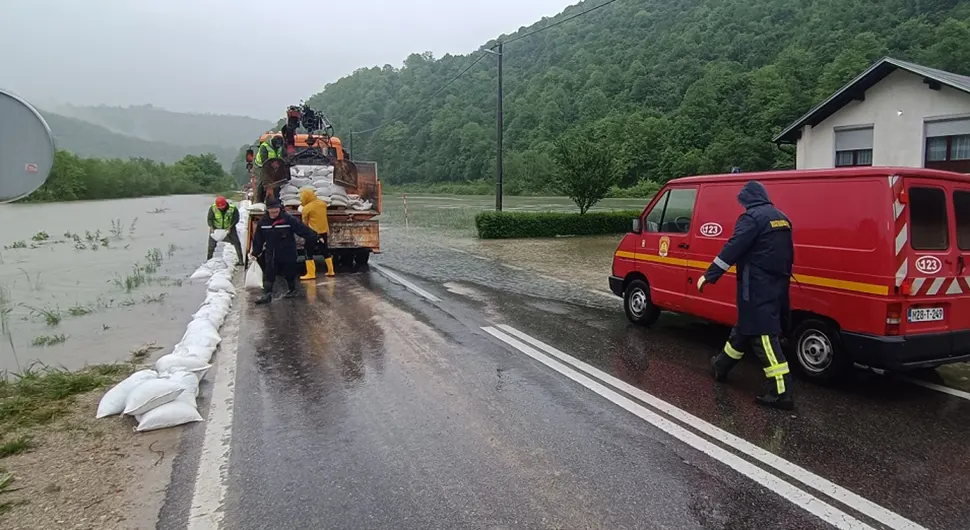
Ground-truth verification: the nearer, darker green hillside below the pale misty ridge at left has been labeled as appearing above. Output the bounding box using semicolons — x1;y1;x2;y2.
41;111;240;169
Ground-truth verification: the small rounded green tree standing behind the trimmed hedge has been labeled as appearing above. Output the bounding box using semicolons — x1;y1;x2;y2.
552;136;620;215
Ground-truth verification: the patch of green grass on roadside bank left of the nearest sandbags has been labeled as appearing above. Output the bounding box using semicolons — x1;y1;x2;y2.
0;363;133;435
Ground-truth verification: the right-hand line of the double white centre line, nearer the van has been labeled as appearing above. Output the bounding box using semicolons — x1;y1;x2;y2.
498;325;925;530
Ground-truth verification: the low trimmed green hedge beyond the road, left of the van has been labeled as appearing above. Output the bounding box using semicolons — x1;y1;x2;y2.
475;211;640;239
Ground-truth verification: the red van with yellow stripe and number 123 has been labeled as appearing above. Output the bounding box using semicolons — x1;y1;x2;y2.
610;167;970;379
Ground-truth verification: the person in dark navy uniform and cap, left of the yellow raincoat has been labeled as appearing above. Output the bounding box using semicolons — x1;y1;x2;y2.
250;197;317;305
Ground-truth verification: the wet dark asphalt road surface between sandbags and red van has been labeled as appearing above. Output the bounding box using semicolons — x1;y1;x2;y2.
159;229;970;529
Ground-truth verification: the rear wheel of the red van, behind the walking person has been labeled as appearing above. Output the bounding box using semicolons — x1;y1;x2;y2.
789;318;852;381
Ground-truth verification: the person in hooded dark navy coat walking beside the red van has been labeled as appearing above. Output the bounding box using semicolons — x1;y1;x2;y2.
697;180;795;410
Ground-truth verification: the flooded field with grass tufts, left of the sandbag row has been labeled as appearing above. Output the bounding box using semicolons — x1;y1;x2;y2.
0;196;219;372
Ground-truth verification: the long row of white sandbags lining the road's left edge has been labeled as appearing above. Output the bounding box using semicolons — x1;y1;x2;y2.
97;201;249;432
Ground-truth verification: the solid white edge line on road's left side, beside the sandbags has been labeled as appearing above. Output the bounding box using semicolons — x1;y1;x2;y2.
187;300;241;530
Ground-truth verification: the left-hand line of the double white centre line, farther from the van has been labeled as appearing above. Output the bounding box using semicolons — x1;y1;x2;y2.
482;327;874;530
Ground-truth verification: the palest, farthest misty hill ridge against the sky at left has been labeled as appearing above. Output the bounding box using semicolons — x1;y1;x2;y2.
48;105;274;150
